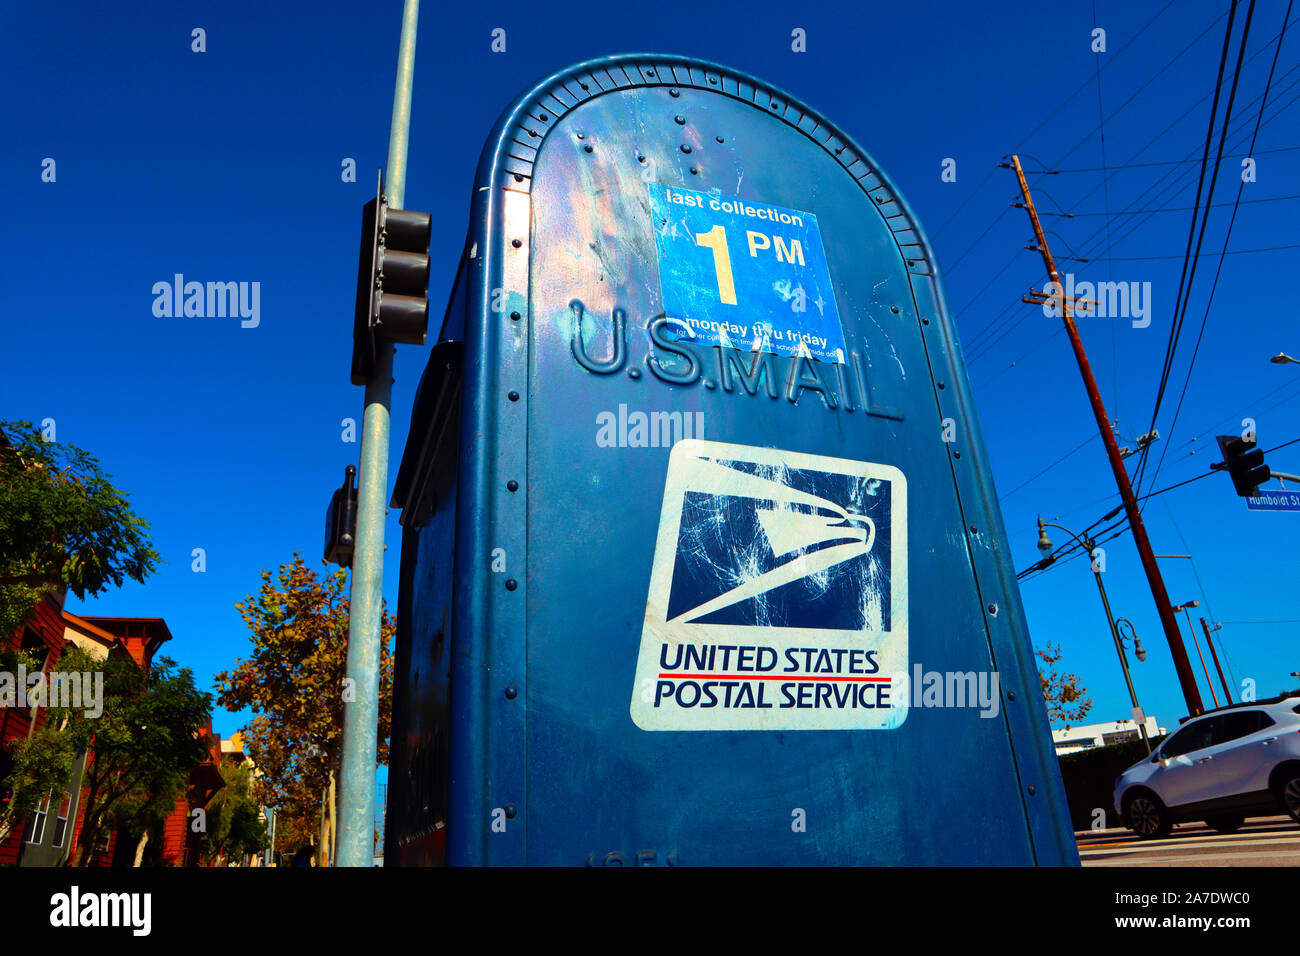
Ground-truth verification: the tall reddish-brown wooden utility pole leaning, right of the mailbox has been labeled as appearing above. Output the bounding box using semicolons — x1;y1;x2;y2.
1001;156;1205;717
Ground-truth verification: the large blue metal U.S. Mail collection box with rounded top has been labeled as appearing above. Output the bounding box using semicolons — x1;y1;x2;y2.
385;55;1078;865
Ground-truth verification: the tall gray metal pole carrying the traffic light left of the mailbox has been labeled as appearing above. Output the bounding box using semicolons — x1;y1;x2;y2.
335;0;420;866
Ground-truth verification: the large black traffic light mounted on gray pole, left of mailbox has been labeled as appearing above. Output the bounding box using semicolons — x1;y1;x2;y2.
352;183;430;385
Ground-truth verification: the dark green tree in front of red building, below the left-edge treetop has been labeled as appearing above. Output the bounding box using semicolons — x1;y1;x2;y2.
68;654;212;866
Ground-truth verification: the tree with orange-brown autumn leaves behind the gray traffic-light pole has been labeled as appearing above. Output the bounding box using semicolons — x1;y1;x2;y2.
216;553;397;865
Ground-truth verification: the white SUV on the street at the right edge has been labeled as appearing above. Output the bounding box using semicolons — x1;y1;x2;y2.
1115;697;1300;839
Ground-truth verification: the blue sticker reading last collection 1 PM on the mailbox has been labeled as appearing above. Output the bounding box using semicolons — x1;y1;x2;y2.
646;182;844;363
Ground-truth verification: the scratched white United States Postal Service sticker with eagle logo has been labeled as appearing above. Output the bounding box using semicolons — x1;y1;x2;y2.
631;440;907;731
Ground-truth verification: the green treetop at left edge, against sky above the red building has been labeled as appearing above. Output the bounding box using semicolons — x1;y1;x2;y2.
0;421;160;636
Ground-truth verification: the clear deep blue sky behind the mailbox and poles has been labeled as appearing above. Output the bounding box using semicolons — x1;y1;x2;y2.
0;0;1300;734
